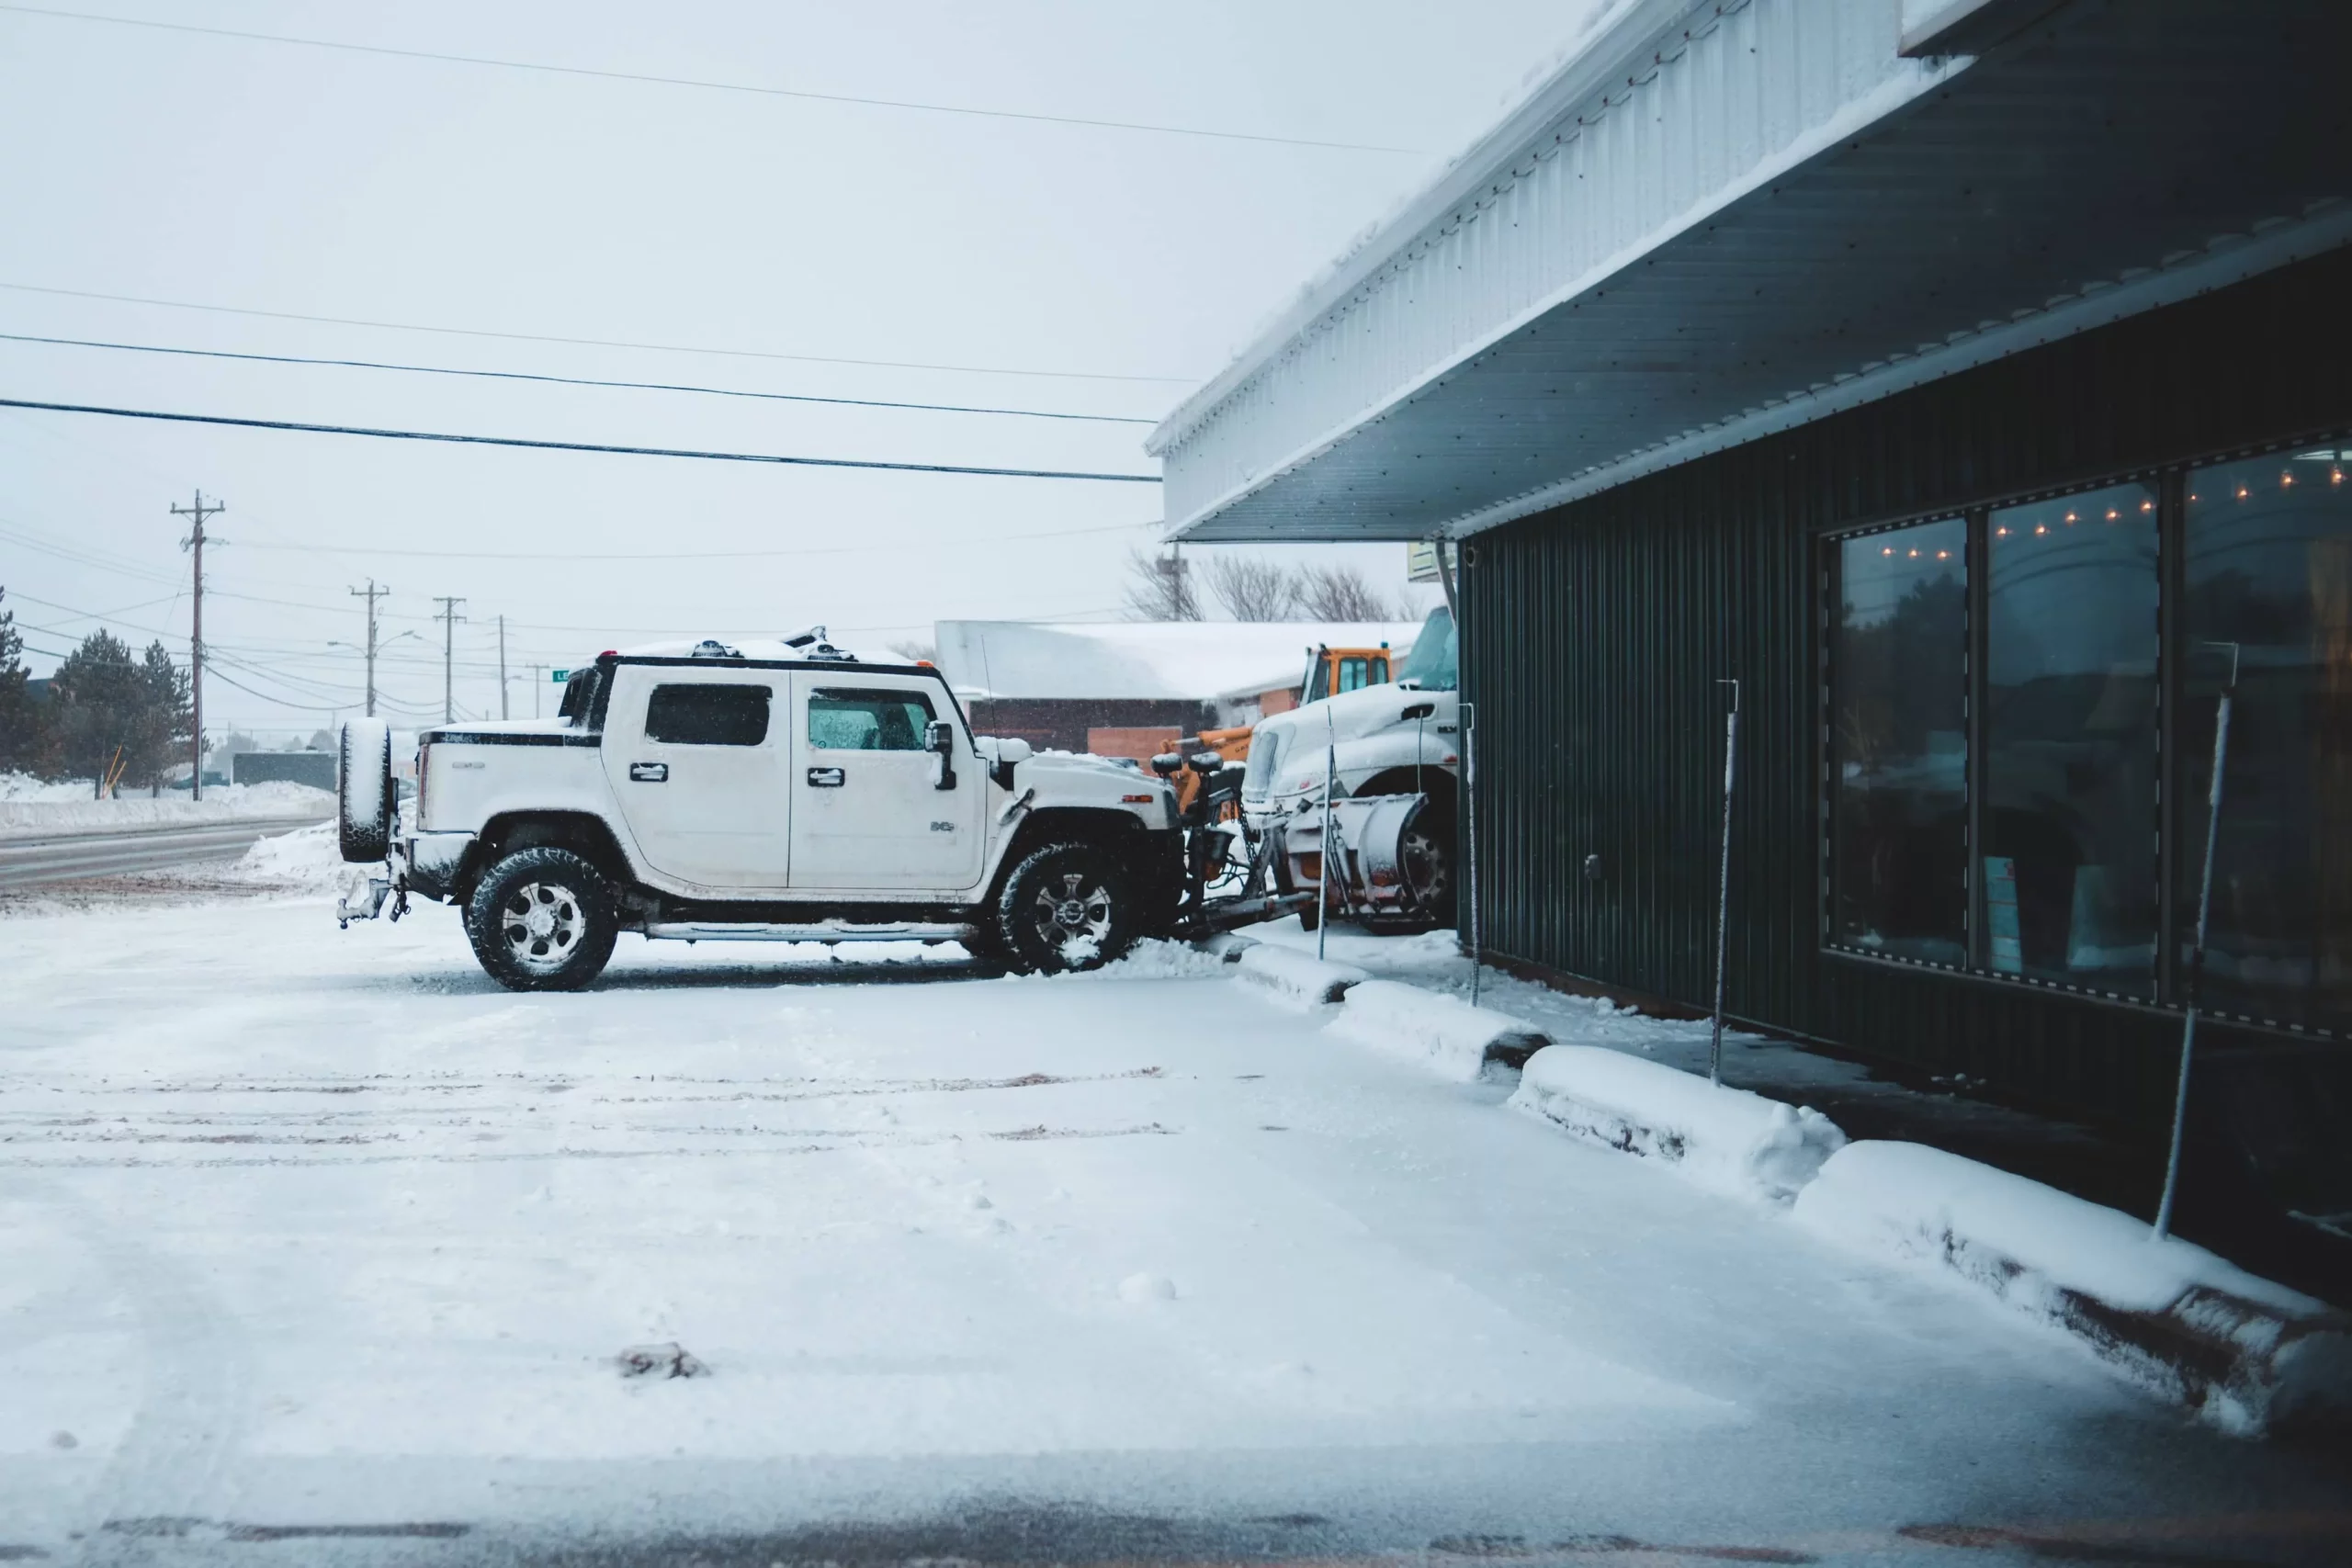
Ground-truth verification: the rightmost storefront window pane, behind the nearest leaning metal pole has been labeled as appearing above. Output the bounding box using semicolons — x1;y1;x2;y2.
2173;446;2352;1030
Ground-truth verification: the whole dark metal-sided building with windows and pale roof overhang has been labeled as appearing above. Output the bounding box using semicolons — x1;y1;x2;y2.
1152;0;2352;1175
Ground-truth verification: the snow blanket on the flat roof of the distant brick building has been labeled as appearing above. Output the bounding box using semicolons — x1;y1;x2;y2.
936;621;1420;701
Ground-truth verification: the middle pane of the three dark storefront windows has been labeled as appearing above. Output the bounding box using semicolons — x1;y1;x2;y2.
1975;482;2159;997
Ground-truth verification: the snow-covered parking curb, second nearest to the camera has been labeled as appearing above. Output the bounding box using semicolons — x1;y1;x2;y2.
1510;1046;1847;1203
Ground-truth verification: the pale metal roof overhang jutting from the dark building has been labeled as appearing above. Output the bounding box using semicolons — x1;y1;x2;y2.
1152;0;2352;541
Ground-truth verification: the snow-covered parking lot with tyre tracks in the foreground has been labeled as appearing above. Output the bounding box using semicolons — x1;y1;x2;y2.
0;869;2352;1568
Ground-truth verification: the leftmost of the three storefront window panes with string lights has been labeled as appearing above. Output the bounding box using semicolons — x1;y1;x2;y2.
1830;517;1969;964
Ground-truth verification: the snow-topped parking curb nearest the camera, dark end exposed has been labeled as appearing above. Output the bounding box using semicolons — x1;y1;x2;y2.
1797;1143;2352;1437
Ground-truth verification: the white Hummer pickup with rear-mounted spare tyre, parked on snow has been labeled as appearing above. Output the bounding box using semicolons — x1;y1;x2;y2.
341;627;1194;989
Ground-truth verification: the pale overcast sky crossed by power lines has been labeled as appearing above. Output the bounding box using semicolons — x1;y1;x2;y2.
0;0;1592;728
